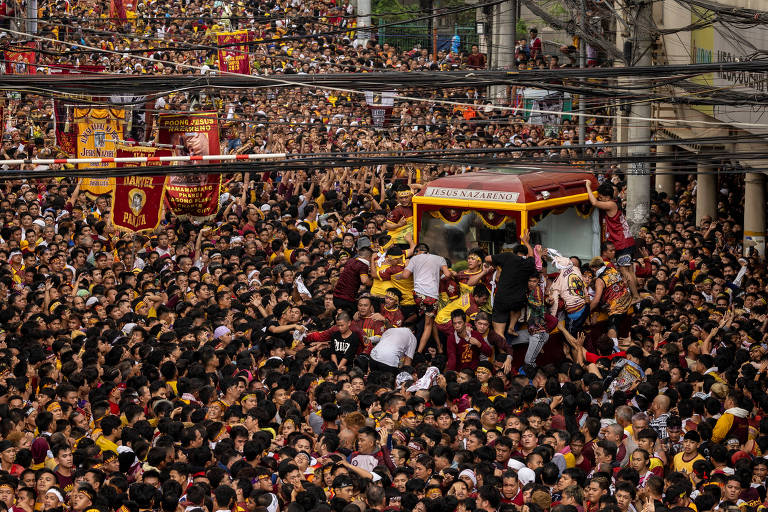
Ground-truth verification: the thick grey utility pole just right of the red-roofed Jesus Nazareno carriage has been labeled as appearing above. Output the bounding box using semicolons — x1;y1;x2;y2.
625;0;656;234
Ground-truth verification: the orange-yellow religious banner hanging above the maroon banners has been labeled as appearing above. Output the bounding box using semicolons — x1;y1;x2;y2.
74;108;125;196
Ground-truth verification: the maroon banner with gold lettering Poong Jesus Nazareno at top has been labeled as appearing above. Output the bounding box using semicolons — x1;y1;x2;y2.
157;112;221;221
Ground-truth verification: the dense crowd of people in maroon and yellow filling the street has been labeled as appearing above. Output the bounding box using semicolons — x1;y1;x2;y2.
0;0;768;512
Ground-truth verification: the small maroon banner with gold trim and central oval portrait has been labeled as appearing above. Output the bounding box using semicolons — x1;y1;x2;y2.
112;176;165;233
